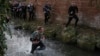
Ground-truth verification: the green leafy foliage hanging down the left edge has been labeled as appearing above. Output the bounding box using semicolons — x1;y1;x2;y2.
0;0;8;56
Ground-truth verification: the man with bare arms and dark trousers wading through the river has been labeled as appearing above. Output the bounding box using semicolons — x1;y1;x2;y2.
30;26;45;54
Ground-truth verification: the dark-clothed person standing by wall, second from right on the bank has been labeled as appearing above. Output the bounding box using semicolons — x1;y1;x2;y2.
43;4;51;24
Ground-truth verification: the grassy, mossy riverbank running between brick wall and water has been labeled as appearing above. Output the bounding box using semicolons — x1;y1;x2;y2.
13;20;100;51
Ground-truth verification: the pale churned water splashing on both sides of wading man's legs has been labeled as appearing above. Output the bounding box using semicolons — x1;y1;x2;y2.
5;25;64;56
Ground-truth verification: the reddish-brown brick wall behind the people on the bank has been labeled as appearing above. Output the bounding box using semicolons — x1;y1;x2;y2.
27;0;100;28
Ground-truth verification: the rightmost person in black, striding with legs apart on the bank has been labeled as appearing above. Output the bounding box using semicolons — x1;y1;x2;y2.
66;2;79;27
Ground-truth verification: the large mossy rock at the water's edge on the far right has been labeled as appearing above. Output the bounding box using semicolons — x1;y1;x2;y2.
77;34;96;50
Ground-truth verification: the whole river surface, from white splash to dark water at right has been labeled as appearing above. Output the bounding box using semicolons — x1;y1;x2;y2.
5;24;100;56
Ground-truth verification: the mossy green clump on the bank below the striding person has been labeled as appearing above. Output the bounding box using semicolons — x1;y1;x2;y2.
62;27;76;43
